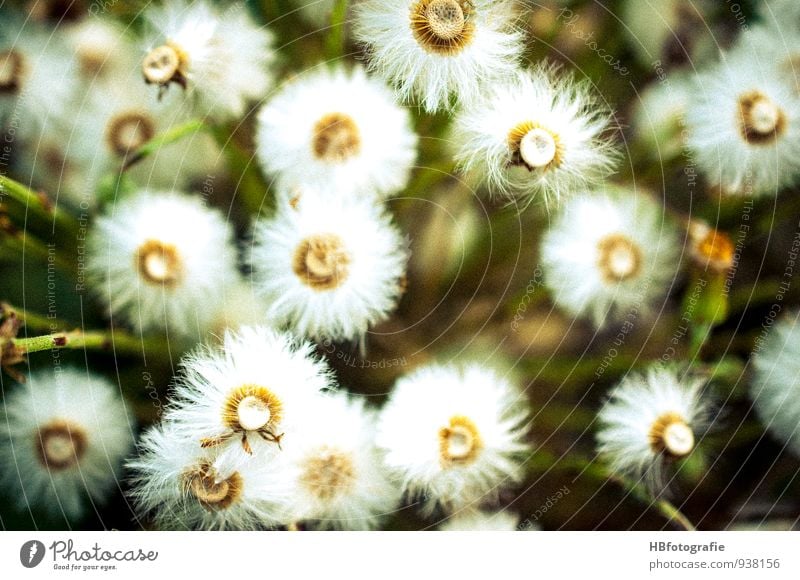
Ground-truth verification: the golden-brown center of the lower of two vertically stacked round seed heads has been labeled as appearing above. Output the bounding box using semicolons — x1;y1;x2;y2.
294;234;350;291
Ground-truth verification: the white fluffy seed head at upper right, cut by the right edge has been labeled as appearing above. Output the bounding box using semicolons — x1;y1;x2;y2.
686;50;800;196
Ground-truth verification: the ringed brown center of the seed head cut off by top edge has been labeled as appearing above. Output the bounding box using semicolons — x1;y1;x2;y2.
411;0;475;55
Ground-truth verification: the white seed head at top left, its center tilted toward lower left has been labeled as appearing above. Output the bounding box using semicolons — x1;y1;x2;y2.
142;0;275;119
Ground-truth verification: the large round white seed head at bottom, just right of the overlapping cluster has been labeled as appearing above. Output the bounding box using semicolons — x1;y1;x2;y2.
376;364;530;511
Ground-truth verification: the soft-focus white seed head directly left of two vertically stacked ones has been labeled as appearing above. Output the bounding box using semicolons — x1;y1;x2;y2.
86;191;237;336
